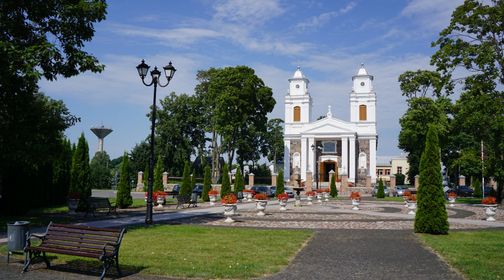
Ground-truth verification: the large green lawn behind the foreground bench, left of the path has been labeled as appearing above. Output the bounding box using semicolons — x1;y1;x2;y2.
1;225;313;279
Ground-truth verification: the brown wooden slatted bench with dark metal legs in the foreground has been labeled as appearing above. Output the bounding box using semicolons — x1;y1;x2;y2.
23;222;126;279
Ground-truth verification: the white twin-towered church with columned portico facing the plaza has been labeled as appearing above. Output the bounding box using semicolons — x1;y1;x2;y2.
284;65;378;187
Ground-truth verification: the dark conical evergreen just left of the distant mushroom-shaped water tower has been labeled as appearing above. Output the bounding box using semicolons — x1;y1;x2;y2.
69;133;91;199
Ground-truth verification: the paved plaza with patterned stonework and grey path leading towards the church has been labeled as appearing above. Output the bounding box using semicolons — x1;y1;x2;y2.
0;199;504;279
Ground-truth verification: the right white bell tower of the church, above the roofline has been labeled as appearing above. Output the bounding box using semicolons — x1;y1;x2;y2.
350;64;376;123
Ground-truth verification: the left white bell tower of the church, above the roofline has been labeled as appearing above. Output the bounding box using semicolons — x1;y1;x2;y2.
284;66;312;125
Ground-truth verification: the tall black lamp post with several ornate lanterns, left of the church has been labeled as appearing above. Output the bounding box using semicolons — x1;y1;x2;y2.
137;60;177;224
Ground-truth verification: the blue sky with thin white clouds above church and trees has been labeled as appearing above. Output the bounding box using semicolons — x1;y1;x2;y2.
40;0;462;161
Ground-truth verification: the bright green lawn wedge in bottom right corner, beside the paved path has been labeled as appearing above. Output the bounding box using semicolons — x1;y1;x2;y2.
419;230;504;279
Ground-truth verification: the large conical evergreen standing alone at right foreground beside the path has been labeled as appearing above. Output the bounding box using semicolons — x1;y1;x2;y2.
415;125;449;234
